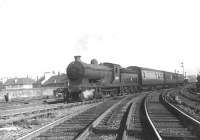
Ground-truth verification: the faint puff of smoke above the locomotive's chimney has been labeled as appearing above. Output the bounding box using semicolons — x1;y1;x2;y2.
74;33;121;58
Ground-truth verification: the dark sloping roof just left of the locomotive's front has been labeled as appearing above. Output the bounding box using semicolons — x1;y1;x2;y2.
43;74;68;86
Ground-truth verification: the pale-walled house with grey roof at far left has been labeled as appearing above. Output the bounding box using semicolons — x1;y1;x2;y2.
4;77;35;90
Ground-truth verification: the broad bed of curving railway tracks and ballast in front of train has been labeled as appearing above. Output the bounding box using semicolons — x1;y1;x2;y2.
0;87;200;140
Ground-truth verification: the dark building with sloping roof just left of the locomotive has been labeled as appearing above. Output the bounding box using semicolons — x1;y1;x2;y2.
42;74;68;87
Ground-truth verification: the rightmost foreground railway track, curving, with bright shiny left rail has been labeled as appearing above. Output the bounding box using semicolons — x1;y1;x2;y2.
145;93;200;140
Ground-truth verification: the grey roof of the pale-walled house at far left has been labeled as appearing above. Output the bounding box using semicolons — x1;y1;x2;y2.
4;78;35;86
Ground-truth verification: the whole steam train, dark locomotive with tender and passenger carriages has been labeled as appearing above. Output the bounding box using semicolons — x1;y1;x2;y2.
67;56;184;100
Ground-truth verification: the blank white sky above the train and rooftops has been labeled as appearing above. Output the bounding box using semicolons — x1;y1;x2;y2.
0;0;200;77
